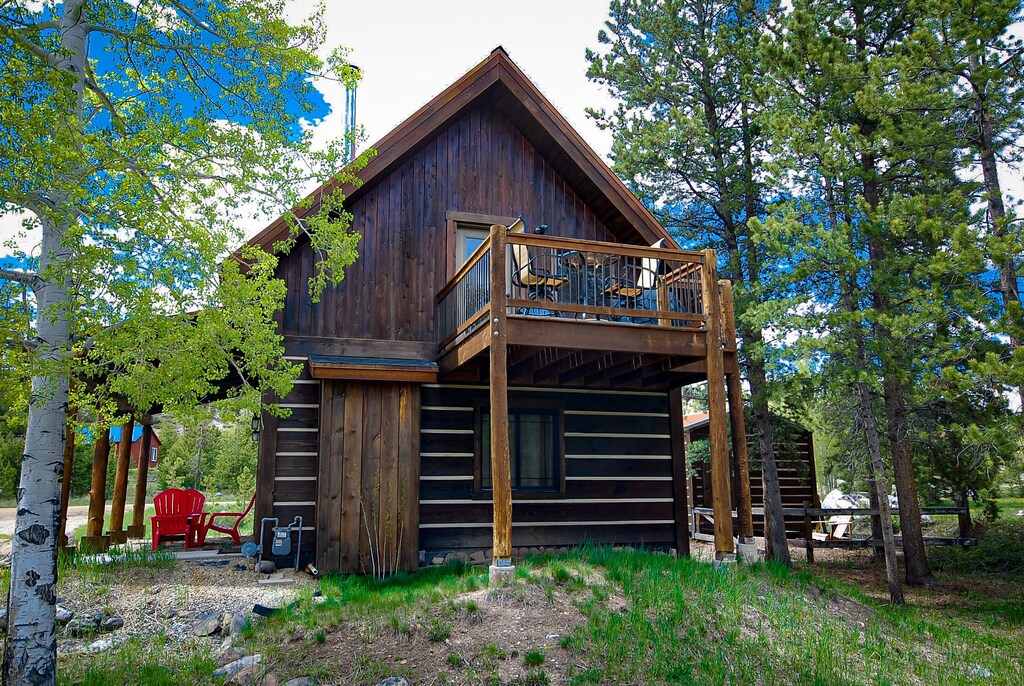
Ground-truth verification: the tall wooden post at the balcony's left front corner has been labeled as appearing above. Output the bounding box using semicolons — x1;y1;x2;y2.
488;224;515;585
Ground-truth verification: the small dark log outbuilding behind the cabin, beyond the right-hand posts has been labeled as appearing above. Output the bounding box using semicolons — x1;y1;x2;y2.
683;413;821;540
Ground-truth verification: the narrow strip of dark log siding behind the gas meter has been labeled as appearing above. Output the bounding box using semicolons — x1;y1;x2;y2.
254;359;321;566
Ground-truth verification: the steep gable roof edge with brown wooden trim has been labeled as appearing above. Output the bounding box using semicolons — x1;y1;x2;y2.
249;46;678;251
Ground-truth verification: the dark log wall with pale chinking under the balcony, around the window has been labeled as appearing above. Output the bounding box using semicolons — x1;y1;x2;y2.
420;385;675;551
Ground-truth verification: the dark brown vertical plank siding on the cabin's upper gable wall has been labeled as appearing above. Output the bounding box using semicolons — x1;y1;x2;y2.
278;100;614;346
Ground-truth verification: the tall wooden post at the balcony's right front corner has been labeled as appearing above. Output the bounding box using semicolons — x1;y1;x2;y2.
700;250;735;562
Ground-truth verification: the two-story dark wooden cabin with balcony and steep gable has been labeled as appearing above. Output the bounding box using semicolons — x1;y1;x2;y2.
252;47;753;578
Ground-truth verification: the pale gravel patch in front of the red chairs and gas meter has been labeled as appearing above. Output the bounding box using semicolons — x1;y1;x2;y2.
51;555;316;654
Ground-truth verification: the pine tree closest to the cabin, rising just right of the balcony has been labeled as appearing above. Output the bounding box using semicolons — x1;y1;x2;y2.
587;0;790;564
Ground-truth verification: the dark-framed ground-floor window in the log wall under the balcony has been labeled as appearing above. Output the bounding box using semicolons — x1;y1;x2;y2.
479;410;561;490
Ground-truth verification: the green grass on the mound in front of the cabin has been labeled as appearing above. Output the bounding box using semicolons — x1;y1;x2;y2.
60;548;1024;685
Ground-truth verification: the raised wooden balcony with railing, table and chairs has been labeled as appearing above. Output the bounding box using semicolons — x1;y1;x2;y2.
437;227;722;390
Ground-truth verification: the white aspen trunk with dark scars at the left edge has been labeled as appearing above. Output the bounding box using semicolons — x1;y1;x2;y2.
3;0;87;686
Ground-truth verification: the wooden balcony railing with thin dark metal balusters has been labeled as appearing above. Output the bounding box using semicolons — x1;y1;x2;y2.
437;229;708;349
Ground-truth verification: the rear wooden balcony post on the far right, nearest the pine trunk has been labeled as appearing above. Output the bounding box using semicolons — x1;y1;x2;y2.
719;280;757;561
